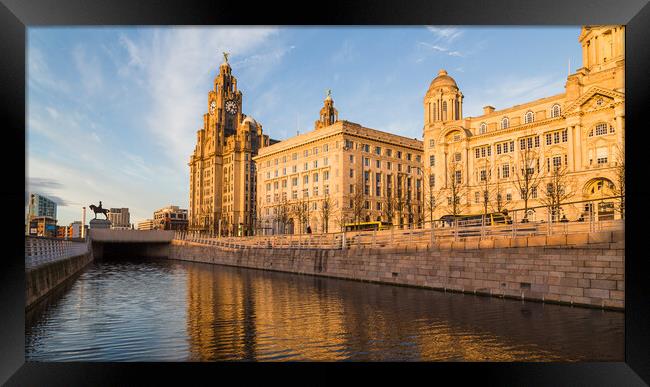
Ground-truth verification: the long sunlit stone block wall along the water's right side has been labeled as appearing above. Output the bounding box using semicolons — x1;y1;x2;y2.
170;231;625;310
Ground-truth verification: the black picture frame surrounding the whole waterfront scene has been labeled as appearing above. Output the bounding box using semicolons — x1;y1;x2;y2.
0;0;650;386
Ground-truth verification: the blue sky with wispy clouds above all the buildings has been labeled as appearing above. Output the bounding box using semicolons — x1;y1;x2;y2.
25;26;582;225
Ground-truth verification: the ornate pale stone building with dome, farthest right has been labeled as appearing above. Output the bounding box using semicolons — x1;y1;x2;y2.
423;26;625;221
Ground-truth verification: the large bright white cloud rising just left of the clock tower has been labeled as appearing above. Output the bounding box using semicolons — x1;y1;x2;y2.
129;28;278;172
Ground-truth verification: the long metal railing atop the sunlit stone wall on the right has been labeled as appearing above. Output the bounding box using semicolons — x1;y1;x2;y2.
175;200;625;249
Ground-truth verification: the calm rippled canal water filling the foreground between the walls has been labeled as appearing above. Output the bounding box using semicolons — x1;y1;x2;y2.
25;260;624;361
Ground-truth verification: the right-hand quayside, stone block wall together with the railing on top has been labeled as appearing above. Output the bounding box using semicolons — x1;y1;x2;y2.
169;220;625;310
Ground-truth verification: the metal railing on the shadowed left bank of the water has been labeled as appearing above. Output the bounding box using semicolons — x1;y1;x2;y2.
25;236;89;270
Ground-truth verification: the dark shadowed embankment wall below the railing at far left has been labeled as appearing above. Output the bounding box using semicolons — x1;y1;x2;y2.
25;252;93;309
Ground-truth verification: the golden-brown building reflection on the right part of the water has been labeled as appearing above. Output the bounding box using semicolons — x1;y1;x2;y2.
187;263;624;361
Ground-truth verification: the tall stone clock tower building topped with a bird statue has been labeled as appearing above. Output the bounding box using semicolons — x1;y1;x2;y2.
189;53;272;235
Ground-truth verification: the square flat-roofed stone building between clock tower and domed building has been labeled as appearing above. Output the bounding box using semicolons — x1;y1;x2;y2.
255;93;424;234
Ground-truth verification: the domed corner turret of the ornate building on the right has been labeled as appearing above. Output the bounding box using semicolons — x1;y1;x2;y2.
424;70;463;126
